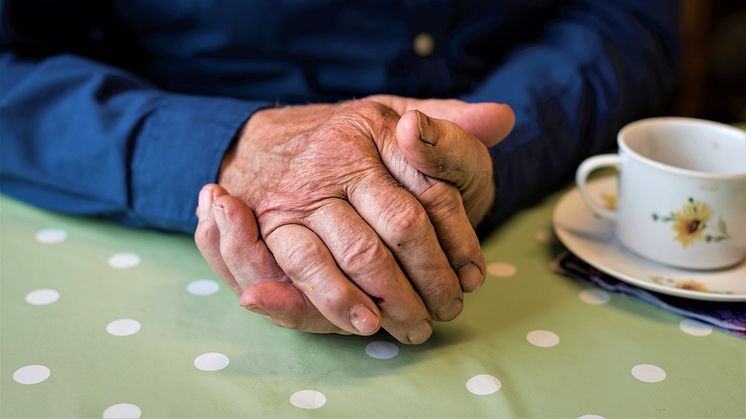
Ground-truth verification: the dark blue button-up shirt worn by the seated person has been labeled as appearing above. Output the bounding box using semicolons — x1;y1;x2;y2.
0;0;678;232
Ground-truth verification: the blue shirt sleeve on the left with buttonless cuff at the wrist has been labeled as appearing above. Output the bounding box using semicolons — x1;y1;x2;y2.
0;51;268;232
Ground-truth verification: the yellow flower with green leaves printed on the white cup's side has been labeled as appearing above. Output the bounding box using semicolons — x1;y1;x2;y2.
652;198;731;248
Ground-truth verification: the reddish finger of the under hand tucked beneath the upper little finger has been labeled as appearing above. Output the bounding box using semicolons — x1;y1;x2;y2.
241;281;350;335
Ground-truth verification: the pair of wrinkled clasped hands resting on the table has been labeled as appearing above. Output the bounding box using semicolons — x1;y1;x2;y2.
195;96;514;344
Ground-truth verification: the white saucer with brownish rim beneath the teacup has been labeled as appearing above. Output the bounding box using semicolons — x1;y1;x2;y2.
552;176;746;301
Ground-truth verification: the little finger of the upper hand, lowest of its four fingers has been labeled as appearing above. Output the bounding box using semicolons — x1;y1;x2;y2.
265;224;381;335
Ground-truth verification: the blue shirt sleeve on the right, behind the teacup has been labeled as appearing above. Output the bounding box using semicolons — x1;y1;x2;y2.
463;0;678;232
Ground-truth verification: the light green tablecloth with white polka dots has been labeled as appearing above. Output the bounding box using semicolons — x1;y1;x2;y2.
0;185;746;418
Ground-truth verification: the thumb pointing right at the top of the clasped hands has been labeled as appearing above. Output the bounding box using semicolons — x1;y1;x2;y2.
369;95;515;147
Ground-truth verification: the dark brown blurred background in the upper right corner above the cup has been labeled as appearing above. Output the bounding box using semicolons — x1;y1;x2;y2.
672;0;746;123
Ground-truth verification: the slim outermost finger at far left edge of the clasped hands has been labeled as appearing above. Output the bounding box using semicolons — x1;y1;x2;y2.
194;184;241;295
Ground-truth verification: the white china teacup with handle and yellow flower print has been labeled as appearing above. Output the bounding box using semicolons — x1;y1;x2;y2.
575;118;746;270
